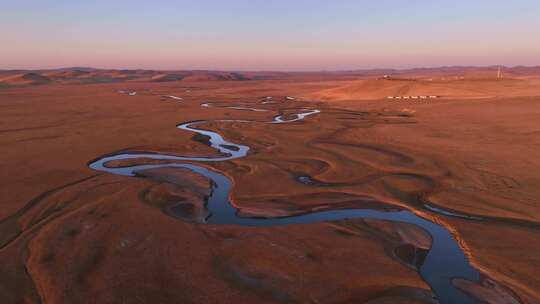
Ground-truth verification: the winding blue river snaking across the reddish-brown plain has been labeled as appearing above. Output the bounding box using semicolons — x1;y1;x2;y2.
89;104;480;304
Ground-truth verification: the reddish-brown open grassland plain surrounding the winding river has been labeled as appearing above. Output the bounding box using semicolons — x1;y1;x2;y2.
0;67;540;304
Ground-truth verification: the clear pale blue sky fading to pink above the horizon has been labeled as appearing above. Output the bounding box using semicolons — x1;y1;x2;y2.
0;0;540;71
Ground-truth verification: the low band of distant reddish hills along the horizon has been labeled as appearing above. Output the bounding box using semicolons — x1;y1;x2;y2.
0;66;540;86
